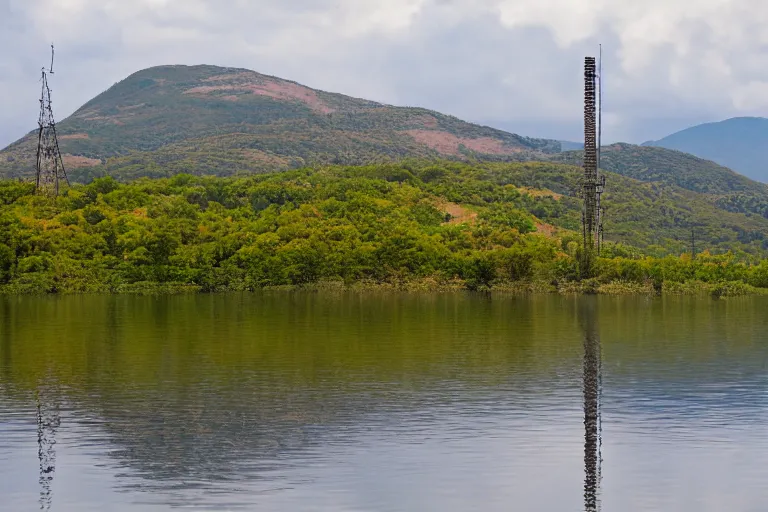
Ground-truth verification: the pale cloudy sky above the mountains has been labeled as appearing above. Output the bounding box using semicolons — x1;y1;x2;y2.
0;0;768;146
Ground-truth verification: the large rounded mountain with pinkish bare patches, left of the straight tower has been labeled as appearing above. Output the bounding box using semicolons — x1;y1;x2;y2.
0;66;560;177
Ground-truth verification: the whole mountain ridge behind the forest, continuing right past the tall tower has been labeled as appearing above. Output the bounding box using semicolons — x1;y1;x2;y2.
0;66;768;254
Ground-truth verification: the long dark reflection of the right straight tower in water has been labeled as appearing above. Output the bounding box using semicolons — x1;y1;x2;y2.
579;298;602;512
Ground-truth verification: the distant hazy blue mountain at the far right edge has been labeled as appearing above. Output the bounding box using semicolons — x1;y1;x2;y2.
643;117;768;182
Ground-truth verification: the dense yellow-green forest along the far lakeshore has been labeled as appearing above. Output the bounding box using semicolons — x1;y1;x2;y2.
0;162;768;295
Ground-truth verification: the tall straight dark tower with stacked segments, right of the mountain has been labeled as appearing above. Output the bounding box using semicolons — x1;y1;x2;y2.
581;48;605;269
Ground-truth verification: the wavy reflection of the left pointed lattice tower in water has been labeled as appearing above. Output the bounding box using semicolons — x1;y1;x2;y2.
35;388;61;510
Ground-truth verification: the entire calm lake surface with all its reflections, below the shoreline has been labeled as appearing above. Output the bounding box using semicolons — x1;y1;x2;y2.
0;294;768;512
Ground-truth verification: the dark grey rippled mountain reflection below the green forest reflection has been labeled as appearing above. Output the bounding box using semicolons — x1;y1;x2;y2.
67;377;536;500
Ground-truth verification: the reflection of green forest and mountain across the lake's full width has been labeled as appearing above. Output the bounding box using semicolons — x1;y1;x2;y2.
0;294;768;498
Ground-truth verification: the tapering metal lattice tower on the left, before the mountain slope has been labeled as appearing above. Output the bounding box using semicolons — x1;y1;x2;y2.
36;45;69;197
